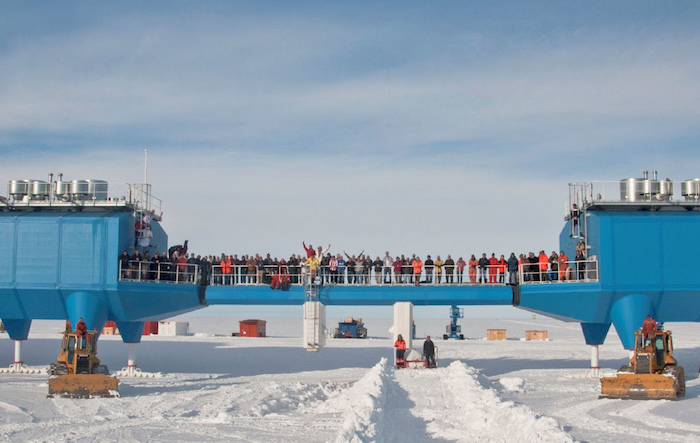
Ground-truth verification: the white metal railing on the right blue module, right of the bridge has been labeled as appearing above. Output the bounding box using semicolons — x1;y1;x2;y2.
519;259;600;285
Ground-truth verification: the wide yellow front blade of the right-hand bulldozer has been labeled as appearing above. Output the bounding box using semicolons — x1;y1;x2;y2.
599;373;680;400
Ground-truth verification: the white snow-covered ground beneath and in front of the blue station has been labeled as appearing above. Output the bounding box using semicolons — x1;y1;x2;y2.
0;317;700;442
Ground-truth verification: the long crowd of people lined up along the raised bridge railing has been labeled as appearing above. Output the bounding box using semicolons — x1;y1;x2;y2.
120;241;587;289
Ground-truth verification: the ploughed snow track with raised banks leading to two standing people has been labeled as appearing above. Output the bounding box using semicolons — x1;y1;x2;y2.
324;359;573;443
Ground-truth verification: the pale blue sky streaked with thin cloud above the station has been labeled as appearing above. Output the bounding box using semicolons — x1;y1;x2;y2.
0;1;700;266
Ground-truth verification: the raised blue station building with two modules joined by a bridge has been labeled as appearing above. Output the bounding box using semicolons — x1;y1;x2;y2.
0;172;700;372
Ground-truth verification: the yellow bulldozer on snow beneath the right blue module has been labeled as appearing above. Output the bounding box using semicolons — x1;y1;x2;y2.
600;330;685;400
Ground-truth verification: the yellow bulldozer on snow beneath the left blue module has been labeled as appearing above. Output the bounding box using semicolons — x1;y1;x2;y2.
49;330;119;398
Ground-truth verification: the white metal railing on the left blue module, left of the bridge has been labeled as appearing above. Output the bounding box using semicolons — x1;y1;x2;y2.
119;261;201;284
